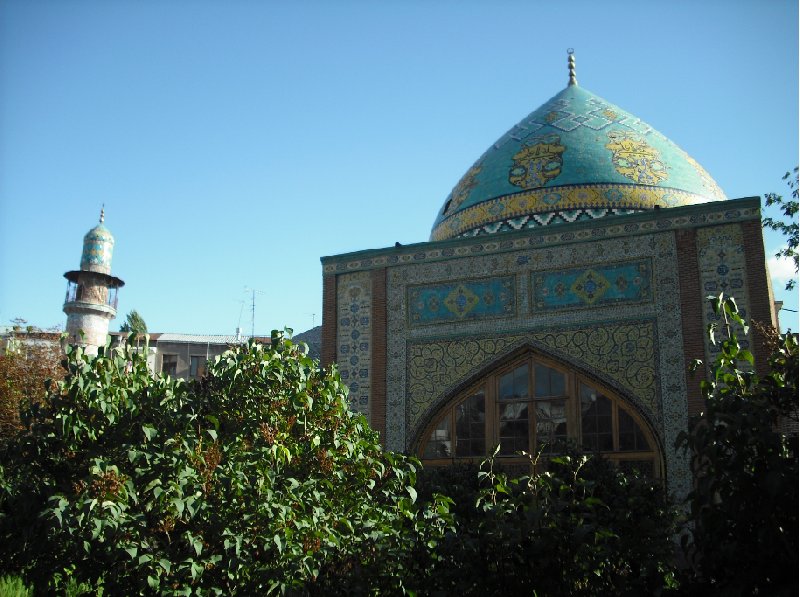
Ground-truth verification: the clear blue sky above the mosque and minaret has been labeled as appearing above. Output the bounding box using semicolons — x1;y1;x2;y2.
0;0;798;333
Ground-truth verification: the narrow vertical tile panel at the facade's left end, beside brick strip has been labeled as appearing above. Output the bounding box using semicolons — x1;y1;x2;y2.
336;272;372;418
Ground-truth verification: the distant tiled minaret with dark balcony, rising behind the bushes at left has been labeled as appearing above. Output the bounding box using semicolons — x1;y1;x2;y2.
64;209;125;354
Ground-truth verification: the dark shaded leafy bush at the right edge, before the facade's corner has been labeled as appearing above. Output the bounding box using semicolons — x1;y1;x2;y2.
679;296;798;595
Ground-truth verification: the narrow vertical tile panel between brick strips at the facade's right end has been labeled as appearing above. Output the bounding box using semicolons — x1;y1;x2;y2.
697;224;751;362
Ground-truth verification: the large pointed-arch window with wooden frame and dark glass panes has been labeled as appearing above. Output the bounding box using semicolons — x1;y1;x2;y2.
419;354;661;477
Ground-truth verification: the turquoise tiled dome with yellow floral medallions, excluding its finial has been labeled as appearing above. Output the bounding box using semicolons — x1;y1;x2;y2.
431;83;726;240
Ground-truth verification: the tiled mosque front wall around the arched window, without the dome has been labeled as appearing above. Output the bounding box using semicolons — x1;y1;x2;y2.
322;199;771;494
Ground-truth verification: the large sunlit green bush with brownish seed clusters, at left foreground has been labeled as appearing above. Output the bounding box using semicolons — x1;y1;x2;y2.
0;337;448;594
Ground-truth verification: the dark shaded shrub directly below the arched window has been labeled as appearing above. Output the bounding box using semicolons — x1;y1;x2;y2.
428;453;676;596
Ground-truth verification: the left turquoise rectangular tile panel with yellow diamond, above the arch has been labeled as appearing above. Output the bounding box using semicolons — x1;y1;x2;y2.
407;276;516;326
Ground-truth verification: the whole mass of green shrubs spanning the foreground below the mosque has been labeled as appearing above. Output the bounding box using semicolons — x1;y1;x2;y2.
0;299;798;596
